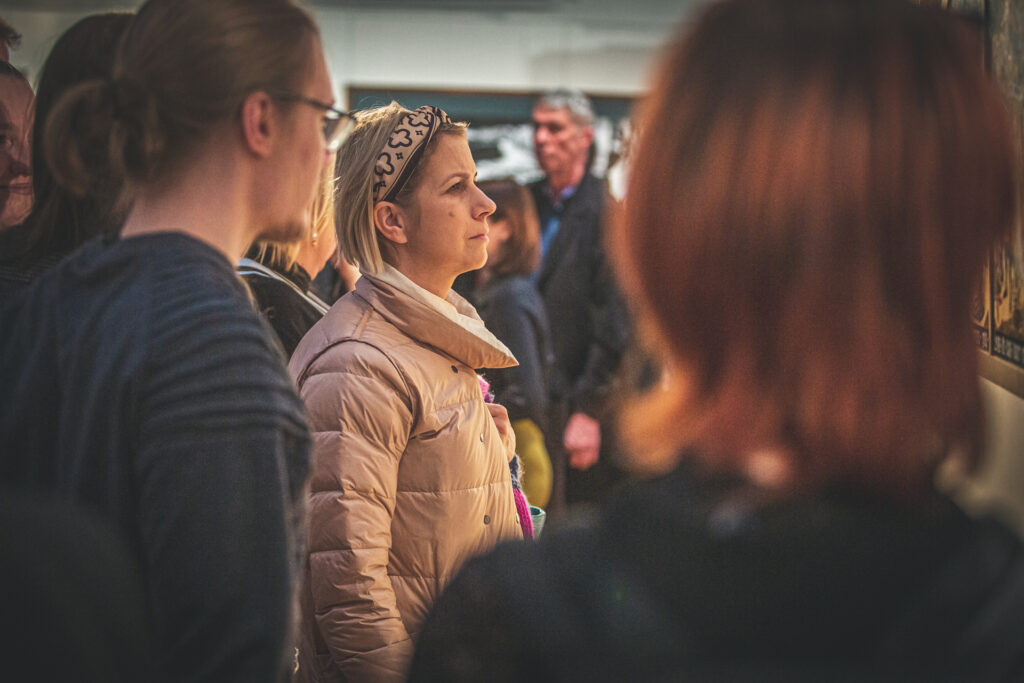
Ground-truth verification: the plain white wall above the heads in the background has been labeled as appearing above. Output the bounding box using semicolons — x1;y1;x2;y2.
0;0;694;97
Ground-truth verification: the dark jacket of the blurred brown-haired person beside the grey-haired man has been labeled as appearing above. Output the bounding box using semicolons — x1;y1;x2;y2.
473;275;554;432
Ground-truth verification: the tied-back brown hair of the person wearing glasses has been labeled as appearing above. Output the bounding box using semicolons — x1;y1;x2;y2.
44;0;318;202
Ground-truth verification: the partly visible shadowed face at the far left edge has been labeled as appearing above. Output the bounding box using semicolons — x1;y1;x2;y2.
0;76;34;228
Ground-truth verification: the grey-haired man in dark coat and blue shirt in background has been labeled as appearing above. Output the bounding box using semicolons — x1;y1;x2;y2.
529;90;630;510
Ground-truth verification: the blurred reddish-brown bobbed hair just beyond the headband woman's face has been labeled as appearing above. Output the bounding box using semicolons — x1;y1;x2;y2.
479;178;541;275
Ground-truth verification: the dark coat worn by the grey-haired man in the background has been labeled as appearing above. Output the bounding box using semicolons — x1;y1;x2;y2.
529;173;630;418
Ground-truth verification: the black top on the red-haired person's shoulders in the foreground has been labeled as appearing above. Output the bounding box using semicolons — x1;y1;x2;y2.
411;467;1024;683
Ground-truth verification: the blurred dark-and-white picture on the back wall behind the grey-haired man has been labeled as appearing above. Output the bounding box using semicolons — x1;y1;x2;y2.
347;86;633;182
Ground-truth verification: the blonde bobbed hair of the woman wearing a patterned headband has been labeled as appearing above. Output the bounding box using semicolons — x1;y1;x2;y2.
335;101;466;274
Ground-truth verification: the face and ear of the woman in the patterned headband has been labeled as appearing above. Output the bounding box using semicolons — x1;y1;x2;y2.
399;133;495;295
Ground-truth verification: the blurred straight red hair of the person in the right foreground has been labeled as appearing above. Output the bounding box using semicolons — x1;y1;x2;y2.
611;0;1017;499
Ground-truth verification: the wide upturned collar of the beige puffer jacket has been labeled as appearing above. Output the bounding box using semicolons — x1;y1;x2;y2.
355;264;518;369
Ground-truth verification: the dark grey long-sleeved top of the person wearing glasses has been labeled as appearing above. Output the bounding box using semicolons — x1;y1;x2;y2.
0;233;309;682
